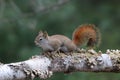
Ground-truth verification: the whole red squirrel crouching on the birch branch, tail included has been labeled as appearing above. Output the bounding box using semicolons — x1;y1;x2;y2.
35;24;101;52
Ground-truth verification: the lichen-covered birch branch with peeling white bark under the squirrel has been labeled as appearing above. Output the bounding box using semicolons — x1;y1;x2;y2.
0;50;120;80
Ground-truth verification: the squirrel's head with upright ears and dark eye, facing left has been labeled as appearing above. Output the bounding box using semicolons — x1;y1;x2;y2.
35;31;48;47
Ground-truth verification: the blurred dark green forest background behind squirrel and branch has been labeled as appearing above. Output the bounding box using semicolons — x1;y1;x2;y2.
0;0;120;80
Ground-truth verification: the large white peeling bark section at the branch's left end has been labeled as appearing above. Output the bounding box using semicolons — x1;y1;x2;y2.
0;56;52;80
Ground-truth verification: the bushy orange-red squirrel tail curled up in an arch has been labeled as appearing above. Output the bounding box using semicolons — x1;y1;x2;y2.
73;24;101;48
